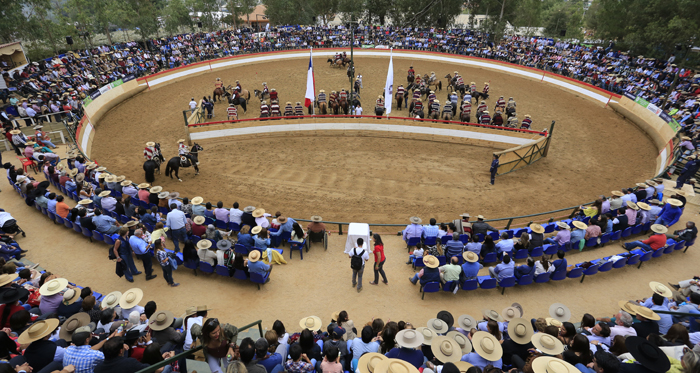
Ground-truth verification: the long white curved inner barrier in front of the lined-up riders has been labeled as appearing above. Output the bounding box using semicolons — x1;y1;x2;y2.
190;122;533;146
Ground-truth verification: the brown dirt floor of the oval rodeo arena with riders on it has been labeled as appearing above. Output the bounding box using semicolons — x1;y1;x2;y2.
92;57;656;223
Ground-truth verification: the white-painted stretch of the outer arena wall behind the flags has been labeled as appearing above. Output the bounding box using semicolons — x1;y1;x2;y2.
148;50;615;104
